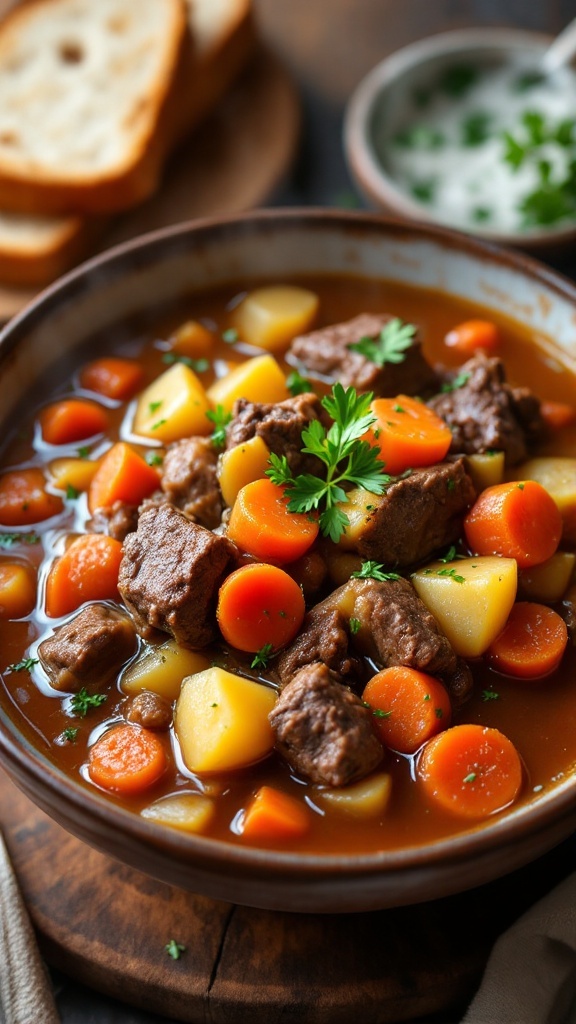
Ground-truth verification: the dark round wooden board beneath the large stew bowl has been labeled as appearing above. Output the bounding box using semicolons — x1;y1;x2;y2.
0;772;576;1024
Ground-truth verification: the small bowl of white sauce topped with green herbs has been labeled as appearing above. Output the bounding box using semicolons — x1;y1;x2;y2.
344;28;576;252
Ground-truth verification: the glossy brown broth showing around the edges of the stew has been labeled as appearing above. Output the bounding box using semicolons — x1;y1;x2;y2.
0;278;576;853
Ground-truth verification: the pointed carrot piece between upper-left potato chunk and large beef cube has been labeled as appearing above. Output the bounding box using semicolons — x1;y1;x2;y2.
88;441;160;512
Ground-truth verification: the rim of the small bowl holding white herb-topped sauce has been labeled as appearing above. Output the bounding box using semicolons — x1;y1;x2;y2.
342;27;576;252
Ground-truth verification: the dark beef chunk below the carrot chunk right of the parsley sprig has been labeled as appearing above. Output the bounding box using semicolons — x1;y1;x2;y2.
344;459;476;566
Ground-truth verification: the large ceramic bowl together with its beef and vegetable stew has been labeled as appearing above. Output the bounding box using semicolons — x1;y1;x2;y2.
0;210;576;912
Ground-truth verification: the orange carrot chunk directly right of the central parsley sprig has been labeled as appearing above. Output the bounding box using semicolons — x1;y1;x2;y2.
366;394;452;475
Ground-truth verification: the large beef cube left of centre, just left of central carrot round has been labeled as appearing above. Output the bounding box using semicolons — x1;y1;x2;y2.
118;504;236;650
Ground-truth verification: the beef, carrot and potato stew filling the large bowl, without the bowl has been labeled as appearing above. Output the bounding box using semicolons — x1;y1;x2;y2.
0;278;576;853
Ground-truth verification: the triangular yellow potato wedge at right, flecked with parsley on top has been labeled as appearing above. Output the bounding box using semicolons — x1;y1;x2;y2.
412;555;518;657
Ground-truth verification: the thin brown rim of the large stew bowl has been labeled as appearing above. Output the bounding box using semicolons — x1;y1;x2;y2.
0;207;576;882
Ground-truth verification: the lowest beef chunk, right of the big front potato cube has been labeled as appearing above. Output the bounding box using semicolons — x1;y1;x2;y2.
270;665;383;785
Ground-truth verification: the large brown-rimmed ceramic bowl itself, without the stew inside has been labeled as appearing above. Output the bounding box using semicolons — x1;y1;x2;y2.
0;210;576;912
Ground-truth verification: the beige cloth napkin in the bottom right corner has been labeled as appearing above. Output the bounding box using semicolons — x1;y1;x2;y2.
461;874;576;1024
